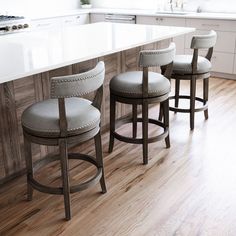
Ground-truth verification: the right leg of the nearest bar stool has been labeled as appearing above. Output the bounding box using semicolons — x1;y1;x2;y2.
94;131;107;193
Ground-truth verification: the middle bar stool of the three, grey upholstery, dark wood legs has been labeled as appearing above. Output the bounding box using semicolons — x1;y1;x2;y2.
109;43;175;164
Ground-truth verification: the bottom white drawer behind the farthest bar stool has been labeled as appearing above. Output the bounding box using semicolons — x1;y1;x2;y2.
185;49;234;74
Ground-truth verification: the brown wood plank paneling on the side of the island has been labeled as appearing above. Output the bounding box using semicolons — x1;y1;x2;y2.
0;41;160;183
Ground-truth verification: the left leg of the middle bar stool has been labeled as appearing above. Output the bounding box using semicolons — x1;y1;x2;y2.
108;94;116;153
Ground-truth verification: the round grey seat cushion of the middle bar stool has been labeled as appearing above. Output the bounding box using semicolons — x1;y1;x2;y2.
110;71;170;98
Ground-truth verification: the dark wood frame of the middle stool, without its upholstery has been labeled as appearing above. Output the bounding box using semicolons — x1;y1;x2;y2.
109;44;173;164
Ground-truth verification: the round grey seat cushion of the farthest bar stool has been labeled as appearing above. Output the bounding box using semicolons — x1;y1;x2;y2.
173;55;211;75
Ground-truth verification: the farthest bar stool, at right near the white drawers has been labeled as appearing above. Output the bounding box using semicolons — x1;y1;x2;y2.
170;30;217;130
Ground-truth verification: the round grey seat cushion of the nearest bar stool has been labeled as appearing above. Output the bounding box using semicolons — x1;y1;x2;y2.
22;97;100;137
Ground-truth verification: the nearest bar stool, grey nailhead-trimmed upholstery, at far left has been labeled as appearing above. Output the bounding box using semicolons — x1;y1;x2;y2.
22;62;106;220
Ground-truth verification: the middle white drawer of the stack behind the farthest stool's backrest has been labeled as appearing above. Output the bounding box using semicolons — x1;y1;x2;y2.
185;30;236;53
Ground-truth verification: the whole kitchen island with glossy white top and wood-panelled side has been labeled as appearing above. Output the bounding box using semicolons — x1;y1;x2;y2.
0;23;194;184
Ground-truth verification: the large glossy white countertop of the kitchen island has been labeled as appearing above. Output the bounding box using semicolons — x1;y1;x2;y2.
0;22;195;83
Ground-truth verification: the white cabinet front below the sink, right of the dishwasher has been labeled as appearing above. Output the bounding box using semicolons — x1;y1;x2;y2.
136;16;185;26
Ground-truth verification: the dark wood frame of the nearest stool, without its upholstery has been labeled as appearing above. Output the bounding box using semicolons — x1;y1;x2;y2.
23;61;107;220
